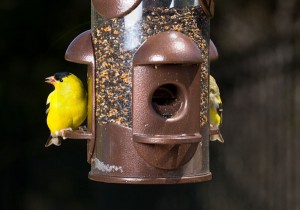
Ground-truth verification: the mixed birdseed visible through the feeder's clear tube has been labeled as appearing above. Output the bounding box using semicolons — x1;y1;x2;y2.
92;6;209;127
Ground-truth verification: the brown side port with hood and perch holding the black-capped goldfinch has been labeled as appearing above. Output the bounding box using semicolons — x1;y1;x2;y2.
64;30;95;163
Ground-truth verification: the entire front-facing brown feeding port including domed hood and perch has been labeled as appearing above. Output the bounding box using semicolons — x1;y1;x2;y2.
132;31;202;169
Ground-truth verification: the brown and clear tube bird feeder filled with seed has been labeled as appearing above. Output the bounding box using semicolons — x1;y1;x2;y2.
64;0;216;184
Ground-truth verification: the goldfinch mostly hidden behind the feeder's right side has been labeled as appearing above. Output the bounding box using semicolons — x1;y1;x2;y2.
209;76;224;143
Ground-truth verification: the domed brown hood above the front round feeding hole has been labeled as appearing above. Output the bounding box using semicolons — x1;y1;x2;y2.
133;31;203;65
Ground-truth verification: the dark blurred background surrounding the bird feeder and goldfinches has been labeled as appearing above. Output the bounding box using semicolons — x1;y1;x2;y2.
0;0;300;210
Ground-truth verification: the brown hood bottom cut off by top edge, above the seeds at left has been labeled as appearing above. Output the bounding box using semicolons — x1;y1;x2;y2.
92;0;141;19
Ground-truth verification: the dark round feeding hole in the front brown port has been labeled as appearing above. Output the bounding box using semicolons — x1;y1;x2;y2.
152;84;183;118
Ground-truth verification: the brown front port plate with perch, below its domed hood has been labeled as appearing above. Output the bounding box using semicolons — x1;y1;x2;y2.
133;64;202;169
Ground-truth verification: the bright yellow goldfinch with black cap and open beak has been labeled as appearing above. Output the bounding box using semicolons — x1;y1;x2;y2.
45;72;87;147
